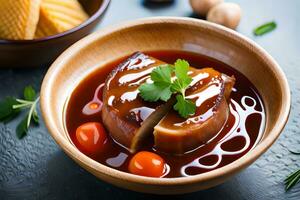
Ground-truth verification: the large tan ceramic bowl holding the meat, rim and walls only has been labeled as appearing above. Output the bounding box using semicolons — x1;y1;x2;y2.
41;17;290;194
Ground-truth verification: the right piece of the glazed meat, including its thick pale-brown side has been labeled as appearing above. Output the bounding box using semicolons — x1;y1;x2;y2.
154;68;235;154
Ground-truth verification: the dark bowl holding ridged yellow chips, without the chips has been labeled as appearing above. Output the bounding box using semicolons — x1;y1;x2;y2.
0;0;110;68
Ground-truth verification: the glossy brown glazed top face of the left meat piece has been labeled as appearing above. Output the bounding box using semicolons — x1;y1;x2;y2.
103;53;165;128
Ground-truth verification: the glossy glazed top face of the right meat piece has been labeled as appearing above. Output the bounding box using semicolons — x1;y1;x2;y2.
160;68;224;130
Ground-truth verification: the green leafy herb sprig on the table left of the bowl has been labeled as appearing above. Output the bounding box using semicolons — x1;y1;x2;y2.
0;86;40;139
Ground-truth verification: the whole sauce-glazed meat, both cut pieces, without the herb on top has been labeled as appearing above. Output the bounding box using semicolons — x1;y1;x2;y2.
102;53;234;154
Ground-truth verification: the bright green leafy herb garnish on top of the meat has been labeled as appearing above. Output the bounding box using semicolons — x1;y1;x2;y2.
139;59;196;118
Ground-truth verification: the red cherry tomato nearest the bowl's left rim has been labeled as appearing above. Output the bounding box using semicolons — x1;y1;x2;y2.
76;122;107;153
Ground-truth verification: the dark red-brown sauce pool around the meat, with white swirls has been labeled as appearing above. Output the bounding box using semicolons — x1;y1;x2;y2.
66;51;265;177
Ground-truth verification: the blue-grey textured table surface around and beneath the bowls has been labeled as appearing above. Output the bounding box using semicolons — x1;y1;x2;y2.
0;0;300;199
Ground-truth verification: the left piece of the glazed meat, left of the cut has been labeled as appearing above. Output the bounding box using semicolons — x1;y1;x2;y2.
102;53;173;152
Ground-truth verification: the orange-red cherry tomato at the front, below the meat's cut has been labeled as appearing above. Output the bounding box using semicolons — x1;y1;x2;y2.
129;151;166;177
